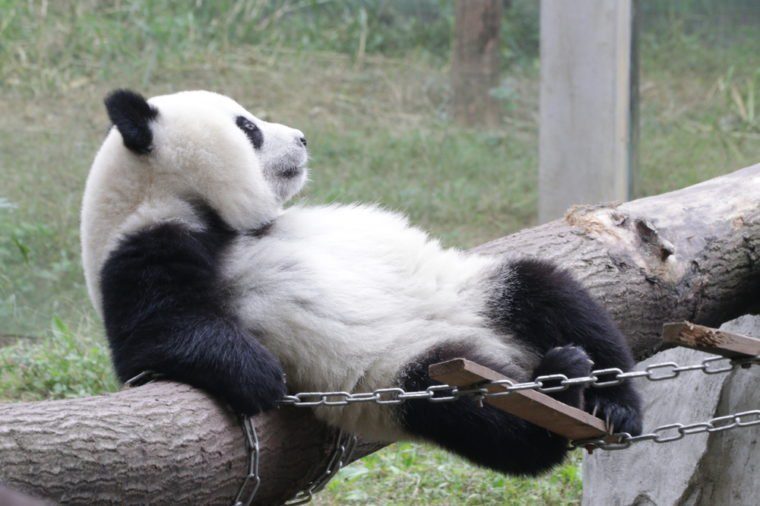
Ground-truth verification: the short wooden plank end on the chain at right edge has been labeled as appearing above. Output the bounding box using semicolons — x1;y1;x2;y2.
662;322;760;358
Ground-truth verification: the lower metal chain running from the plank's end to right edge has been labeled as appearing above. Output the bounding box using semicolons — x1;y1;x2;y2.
571;409;760;450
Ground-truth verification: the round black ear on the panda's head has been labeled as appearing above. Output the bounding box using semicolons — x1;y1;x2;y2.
105;90;158;155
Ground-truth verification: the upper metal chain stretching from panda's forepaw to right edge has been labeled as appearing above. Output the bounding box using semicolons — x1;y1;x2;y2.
280;355;760;407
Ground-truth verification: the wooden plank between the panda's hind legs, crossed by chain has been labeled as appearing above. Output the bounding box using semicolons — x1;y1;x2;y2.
428;358;609;440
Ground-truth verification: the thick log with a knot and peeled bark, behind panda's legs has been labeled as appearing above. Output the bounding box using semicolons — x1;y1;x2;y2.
474;164;760;360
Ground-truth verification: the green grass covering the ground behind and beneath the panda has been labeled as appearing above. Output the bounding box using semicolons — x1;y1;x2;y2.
0;0;760;505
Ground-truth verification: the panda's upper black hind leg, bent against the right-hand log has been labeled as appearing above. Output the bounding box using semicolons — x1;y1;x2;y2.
489;259;641;434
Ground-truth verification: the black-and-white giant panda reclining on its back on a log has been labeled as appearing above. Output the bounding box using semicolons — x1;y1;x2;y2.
81;90;641;475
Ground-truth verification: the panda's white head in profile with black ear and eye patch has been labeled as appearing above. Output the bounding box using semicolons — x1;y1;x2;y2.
100;90;308;232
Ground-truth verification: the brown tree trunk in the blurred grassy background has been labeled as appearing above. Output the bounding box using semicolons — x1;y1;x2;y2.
451;0;502;126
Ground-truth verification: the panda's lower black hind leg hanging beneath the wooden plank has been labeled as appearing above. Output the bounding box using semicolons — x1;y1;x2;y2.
399;347;591;475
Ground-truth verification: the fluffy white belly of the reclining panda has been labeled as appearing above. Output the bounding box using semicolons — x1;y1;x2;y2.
224;206;534;441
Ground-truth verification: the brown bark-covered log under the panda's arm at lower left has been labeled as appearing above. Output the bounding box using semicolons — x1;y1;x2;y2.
0;381;383;505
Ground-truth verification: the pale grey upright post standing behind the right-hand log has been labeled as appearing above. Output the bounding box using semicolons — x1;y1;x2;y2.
539;0;637;223
